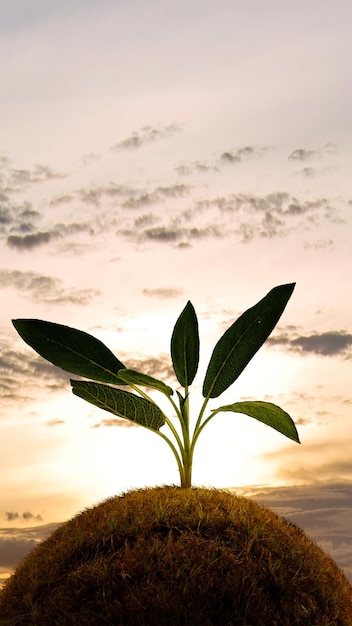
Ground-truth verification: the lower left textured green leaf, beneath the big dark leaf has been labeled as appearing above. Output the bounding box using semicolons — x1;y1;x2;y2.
71;380;165;430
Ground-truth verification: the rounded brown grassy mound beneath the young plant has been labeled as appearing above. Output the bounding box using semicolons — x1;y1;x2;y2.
0;487;352;626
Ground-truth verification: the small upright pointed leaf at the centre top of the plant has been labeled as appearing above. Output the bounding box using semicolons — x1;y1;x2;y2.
171;301;199;387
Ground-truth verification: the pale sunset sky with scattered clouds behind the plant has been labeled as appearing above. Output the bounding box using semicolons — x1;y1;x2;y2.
0;0;352;580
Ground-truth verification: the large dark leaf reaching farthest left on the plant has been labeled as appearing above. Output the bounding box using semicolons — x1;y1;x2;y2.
12;319;125;385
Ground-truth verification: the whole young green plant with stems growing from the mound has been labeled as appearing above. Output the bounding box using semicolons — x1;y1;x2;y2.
13;283;300;487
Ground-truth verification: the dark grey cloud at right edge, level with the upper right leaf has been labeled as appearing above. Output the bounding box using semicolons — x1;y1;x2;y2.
267;330;352;356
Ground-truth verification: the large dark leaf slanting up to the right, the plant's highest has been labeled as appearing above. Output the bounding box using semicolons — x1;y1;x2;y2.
203;283;295;398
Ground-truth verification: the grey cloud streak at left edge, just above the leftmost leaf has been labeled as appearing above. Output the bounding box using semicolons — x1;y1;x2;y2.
0;269;100;305
